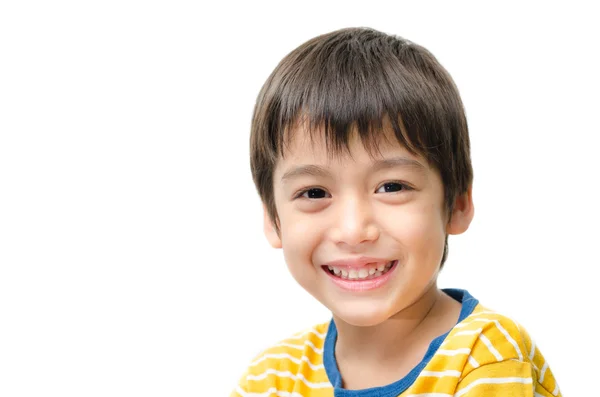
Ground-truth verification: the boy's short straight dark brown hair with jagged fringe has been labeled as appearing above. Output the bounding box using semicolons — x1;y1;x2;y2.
250;28;473;264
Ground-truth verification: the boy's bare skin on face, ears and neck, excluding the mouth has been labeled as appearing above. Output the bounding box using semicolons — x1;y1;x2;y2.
264;123;474;389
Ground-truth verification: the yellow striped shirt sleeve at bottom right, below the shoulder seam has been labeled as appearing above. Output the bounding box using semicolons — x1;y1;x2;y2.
454;360;536;397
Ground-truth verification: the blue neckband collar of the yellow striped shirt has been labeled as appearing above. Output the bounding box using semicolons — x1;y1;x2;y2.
323;289;479;397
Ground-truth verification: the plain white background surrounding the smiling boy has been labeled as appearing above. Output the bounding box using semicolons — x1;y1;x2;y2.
0;1;600;397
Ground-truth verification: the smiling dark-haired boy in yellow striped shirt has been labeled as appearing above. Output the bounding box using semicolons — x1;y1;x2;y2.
232;28;560;397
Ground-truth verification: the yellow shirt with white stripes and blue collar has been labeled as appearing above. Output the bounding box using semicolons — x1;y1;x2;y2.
231;289;561;397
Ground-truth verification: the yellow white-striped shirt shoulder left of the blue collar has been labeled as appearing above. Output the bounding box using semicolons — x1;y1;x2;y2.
231;322;331;395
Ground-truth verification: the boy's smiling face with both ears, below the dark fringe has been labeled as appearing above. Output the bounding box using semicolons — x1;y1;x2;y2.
265;123;473;326
